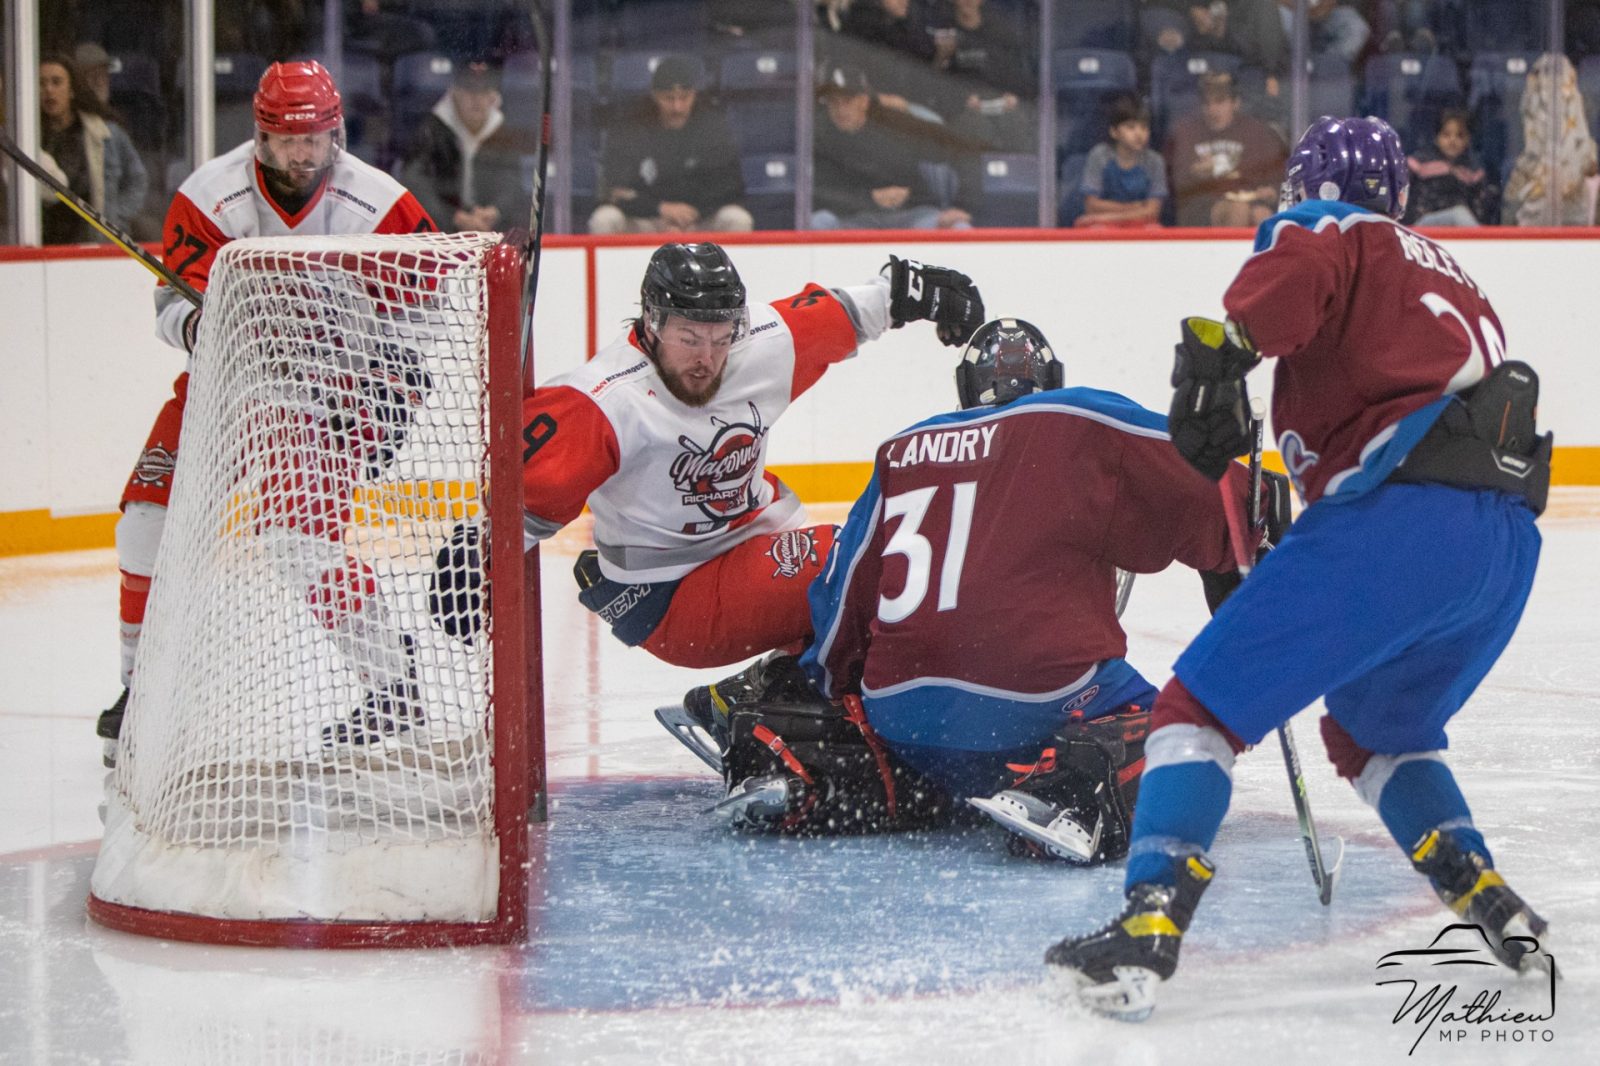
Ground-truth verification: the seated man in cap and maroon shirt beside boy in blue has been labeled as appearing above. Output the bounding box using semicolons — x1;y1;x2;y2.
1166;72;1285;226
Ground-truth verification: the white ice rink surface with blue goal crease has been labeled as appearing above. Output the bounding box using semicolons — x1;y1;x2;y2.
0;490;1600;1066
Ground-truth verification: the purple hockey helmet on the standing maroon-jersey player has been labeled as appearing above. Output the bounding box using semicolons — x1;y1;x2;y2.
1282;115;1410;218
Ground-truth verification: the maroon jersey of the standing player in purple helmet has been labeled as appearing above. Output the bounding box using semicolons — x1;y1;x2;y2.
1222;200;1506;503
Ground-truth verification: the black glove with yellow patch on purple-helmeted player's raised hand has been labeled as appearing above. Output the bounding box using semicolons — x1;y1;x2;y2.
1166;319;1261;482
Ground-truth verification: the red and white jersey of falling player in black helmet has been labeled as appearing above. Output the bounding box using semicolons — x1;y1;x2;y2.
523;279;888;583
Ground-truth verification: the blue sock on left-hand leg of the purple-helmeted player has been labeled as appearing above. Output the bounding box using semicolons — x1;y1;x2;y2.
1123;760;1234;890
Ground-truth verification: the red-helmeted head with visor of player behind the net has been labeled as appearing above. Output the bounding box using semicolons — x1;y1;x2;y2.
254;61;344;195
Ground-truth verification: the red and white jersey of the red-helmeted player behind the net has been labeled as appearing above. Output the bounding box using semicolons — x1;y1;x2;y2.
155;141;437;349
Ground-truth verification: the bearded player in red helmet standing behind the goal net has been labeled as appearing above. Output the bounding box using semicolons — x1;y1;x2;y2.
98;62;435;760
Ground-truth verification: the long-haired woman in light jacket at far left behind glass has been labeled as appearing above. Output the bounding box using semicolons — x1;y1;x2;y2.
38;54;149;245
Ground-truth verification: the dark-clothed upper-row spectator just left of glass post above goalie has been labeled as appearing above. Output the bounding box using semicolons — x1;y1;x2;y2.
934;0;1038;152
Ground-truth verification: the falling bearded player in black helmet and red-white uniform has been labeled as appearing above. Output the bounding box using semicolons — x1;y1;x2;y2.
434;243;984;667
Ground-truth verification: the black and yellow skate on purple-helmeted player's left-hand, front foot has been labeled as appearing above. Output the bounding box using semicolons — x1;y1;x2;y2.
1045;855;1216;1021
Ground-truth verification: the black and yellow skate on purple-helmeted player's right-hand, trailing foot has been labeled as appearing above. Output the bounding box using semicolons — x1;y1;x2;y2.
1411;829;1550;973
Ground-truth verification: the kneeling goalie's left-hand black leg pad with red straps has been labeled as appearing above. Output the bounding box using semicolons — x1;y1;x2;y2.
723;699;955;836
